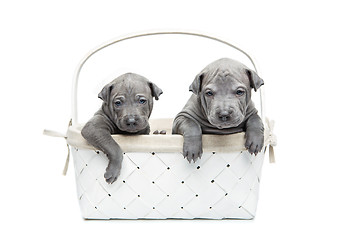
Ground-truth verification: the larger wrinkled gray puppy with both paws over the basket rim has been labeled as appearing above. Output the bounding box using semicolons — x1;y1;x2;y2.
172;58;264;162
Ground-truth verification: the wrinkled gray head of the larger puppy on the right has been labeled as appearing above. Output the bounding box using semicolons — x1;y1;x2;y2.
189;58;264;129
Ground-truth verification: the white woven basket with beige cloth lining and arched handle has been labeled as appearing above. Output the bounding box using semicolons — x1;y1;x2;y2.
46;32;275;219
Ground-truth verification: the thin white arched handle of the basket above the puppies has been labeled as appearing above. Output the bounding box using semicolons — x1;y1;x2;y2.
71;31;264;125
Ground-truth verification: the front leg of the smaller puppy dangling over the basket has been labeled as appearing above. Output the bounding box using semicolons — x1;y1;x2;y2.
81;116;123;184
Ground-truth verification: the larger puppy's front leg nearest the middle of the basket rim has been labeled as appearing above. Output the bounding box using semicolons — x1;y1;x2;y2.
172;116;203;163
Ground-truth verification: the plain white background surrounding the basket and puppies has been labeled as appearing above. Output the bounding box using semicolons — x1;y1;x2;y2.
0;0;360;239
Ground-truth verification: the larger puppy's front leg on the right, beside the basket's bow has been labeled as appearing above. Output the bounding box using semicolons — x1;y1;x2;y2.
245;114;264;155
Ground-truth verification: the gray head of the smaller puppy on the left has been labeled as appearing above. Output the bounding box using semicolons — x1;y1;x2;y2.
98;73;163;133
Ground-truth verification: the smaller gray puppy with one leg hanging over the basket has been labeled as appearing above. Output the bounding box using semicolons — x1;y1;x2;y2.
81;73;162;184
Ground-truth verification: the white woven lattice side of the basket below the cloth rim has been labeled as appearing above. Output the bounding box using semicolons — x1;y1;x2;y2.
71;147;265;219
